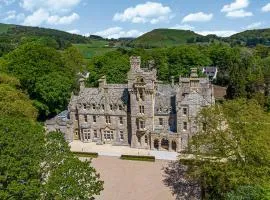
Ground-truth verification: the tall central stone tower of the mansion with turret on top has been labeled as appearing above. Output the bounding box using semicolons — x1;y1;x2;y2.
128;57;157;148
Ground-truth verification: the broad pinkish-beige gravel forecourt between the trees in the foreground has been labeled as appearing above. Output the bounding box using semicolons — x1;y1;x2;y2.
92;156;175;200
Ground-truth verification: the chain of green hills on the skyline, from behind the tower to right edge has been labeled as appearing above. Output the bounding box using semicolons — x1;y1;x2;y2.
127;29;270;48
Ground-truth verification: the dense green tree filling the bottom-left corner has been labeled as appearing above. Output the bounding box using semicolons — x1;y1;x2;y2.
0;114;44;200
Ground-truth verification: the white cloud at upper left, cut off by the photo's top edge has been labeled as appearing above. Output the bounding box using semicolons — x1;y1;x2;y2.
20;0;81;13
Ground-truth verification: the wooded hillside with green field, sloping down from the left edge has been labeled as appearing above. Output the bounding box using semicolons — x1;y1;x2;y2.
0;23;117;59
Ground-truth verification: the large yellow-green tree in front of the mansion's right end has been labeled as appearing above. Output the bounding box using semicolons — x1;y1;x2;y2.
168;99;270;199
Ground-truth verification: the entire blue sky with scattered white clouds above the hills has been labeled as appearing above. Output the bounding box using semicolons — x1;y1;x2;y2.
0;0;270;38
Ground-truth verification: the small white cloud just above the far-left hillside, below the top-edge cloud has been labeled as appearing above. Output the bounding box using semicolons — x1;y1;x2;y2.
23;9;49;26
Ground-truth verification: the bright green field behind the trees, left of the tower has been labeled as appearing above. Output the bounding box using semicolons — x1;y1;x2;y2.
73;40;116;59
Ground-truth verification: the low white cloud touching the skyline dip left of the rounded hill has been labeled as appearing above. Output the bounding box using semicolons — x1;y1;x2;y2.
95;27;144;39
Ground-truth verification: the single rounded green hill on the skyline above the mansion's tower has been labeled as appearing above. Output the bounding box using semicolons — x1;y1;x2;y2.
129;29;202;48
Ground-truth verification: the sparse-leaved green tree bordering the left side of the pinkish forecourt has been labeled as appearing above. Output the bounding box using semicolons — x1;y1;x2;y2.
42;132;103;200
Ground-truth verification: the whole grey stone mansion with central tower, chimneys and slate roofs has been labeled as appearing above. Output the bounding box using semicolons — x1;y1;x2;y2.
46;57;215;151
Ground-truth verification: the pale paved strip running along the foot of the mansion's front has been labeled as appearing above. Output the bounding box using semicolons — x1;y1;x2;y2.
70;141;178;160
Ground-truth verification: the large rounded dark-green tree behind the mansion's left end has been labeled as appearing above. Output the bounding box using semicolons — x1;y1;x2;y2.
1;42;83;120
